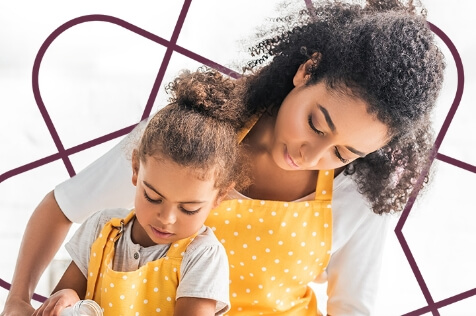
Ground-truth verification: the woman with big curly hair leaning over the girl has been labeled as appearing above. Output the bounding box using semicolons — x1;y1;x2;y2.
2;0;444;315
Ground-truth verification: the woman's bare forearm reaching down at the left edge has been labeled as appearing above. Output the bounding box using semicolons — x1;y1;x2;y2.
2;192;72;316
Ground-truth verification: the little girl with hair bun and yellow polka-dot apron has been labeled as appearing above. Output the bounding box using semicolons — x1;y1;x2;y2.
34;71;249;316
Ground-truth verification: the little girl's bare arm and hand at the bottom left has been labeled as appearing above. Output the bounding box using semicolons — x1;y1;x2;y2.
32;261;87;316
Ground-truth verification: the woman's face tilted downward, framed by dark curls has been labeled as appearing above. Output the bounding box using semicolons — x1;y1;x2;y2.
271;66;388;170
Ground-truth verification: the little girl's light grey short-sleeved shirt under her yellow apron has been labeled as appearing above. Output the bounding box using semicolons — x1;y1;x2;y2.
65;209;230;315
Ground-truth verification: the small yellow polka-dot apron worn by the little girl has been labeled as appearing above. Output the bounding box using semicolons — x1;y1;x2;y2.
86;211;196;316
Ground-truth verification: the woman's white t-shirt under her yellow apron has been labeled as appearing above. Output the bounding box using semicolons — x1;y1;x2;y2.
54;121;390;315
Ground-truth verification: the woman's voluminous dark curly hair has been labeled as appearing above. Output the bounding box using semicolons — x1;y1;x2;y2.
243;0;444;214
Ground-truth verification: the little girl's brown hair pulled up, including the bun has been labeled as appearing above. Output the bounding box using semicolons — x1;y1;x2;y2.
136;67;250;192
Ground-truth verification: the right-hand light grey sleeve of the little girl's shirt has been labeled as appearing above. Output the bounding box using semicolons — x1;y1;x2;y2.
176;228;230;315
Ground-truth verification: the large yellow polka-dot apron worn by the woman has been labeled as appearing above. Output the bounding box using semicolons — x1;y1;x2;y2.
206;170;334;315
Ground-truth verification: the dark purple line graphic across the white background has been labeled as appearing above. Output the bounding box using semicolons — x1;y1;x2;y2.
0;0;476;316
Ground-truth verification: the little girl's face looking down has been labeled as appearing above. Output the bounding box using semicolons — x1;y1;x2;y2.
132;154;219;247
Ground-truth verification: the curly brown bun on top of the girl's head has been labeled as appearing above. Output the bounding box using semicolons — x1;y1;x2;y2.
166;67;243;125
